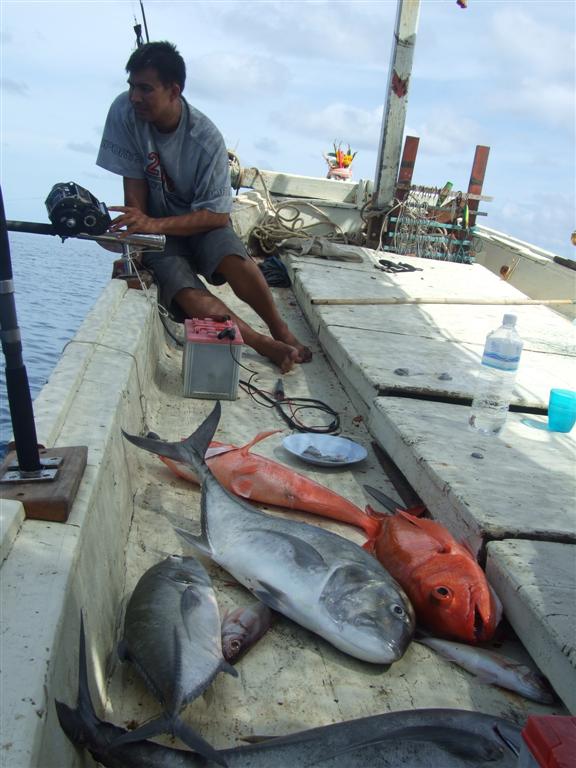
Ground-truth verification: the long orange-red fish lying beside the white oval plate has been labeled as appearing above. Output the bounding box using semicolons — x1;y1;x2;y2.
153;429;382;539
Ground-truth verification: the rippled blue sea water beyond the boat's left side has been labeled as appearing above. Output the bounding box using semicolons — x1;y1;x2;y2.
0;232;112;457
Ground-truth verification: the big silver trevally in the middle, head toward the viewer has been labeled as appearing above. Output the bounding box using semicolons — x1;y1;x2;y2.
124;403;414;664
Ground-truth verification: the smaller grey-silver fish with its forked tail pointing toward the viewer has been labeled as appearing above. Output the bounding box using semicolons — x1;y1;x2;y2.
111;555;238;760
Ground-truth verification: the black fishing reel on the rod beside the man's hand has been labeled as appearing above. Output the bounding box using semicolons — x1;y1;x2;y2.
46;181;112;237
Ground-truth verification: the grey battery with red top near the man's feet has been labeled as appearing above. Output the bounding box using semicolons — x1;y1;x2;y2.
182;318;244;400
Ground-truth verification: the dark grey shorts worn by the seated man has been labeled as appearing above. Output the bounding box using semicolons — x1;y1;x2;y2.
142;226;248;322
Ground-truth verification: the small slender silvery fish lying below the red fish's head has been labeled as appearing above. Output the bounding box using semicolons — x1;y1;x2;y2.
417;637;556;704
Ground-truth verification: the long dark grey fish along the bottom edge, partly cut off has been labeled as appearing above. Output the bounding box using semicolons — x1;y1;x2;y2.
56;625;521;768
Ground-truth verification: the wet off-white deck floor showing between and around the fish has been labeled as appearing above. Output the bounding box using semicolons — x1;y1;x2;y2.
106;276;565;747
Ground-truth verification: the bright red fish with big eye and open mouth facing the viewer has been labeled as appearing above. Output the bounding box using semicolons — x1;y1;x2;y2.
365;510;502;643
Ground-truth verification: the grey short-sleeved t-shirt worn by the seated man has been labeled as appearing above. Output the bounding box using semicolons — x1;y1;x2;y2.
96;91;232;217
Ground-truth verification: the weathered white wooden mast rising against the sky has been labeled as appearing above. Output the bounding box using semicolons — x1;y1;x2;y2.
368;0;420;246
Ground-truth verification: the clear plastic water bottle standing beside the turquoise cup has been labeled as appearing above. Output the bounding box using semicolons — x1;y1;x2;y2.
468;315;523;435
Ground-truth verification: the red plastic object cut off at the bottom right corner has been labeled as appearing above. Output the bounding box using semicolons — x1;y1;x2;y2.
522;715;576;768
